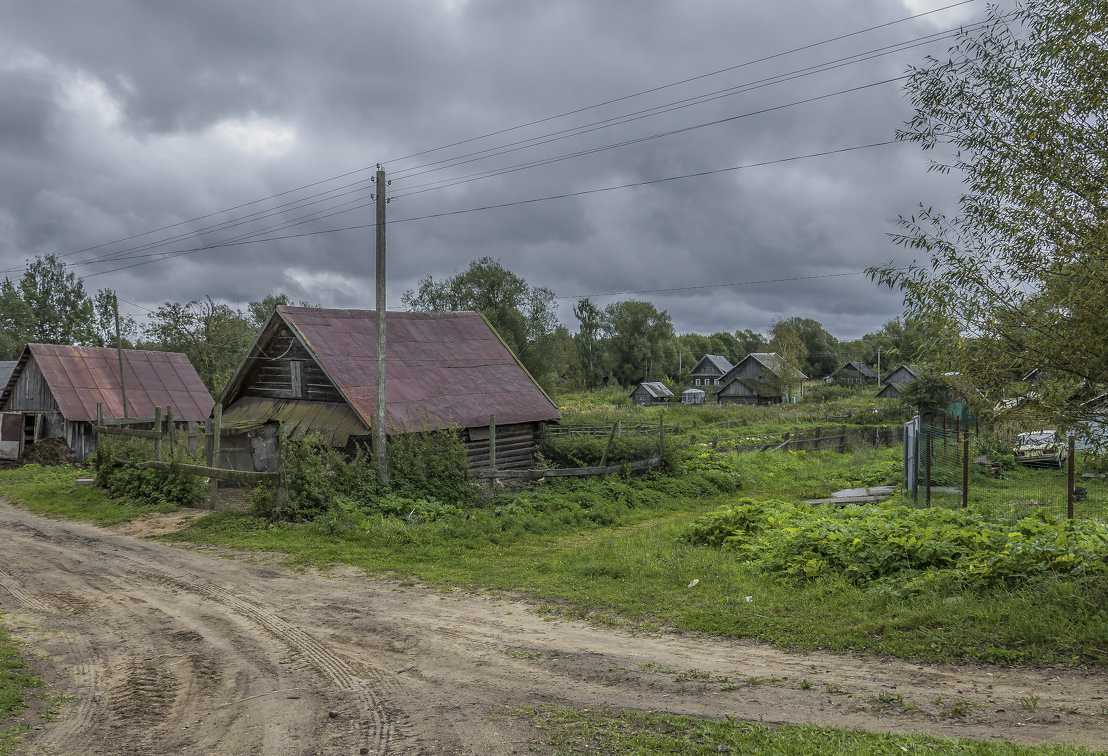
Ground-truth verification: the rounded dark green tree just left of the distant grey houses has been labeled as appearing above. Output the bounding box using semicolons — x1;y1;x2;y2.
602;300;674;387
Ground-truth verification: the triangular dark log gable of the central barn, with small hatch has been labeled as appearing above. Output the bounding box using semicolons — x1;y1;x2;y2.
242;324;345;401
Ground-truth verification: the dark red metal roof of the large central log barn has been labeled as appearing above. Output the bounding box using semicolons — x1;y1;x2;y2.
269;306;560;433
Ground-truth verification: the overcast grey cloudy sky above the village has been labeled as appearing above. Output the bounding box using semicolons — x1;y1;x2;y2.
0;0;986;339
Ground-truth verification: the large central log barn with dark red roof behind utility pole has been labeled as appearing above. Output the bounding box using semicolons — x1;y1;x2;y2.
219;306;561;469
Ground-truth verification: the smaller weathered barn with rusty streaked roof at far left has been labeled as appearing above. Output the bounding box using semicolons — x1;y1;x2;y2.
0;344;215;461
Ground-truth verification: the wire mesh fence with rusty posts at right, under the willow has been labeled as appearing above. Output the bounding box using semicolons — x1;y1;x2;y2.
904;415;1108;520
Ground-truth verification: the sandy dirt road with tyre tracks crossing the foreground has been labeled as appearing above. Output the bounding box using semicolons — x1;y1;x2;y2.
0;496;1108;756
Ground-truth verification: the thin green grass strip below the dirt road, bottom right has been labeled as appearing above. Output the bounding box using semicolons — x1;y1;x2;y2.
514;708;1092;756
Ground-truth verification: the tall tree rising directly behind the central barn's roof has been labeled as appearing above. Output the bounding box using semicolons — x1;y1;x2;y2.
401;257;558;388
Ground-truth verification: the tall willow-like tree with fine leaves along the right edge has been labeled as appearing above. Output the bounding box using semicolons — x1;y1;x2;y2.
870;0;1108;425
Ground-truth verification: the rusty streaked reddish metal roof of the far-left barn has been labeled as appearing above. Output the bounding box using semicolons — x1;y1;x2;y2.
3;344;215;421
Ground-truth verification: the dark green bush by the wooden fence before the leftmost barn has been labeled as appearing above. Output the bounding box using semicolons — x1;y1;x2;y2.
89;436;204;507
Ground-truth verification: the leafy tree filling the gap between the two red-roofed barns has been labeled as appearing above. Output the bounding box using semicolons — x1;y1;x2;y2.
143;297;254;395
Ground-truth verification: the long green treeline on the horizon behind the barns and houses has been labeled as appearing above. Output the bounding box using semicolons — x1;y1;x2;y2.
0;255;925;394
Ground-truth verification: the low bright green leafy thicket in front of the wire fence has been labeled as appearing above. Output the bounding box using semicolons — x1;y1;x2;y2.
683;499;1108;592
